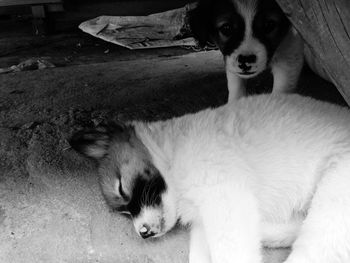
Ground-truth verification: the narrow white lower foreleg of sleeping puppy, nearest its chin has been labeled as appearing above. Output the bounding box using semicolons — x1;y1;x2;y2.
189;223;211;263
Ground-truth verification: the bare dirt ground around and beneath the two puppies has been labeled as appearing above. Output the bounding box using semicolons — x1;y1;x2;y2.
0;27;344;263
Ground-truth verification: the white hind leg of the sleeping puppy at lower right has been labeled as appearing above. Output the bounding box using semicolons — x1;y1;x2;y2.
285;156;350;263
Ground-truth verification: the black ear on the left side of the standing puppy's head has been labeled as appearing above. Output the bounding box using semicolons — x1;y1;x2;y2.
188;3;212;47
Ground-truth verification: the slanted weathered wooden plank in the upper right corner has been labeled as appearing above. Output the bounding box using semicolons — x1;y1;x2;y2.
277;0;350;105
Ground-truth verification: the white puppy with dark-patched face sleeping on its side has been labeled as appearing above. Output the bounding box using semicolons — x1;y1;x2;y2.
70;94;350;263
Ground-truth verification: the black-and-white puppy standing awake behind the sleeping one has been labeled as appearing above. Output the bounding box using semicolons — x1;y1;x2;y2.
189;0;303;101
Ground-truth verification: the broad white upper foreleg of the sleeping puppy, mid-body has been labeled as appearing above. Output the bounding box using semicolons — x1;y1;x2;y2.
198;183;261;263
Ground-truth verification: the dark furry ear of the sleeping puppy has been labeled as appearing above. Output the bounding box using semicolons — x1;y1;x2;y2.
69;128;111;160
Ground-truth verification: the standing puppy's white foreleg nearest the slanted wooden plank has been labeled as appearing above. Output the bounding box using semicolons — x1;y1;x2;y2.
271;29;304;93
